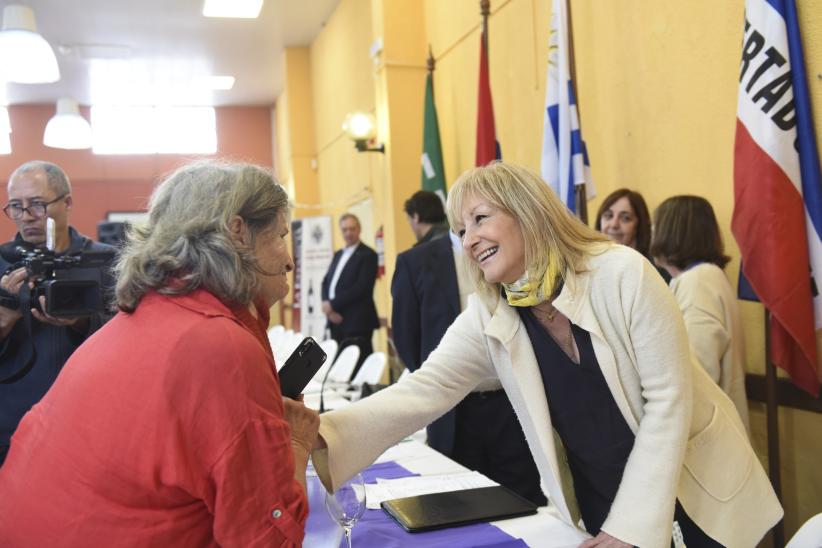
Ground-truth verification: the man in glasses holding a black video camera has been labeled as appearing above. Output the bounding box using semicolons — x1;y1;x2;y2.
0;161;115;465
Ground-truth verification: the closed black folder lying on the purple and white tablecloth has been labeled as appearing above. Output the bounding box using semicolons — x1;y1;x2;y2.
381;485;537;533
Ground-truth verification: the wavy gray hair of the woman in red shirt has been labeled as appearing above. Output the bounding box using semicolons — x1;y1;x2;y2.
115;161;289;312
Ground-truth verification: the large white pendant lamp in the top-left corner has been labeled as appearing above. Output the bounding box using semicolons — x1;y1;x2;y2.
0;6;60;84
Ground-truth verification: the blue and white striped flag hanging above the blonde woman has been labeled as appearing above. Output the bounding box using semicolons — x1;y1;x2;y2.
542;0;595;213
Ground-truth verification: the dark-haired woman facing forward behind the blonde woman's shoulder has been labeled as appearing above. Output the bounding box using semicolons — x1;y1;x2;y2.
594;188;671;282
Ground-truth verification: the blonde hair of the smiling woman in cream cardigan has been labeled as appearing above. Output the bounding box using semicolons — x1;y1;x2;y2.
447;161;609;294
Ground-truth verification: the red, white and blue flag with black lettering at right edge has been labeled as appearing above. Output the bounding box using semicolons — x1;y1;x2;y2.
732;0;822;395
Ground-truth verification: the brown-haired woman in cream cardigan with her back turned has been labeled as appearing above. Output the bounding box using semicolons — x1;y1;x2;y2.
651;196;749;428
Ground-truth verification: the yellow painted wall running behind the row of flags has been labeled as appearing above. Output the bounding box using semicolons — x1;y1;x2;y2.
282;0;822;534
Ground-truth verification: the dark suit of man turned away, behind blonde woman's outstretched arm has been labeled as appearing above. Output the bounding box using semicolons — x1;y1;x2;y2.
391;200;547;505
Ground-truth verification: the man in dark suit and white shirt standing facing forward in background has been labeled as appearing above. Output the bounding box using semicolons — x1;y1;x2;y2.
322;213;380;378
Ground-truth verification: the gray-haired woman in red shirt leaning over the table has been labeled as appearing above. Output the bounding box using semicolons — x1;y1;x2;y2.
0;162;319;547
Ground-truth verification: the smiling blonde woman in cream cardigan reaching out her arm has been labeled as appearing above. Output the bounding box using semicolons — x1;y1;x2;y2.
313;162;782;548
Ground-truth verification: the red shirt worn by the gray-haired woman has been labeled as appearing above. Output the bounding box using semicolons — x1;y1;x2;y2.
0;290;308;548
